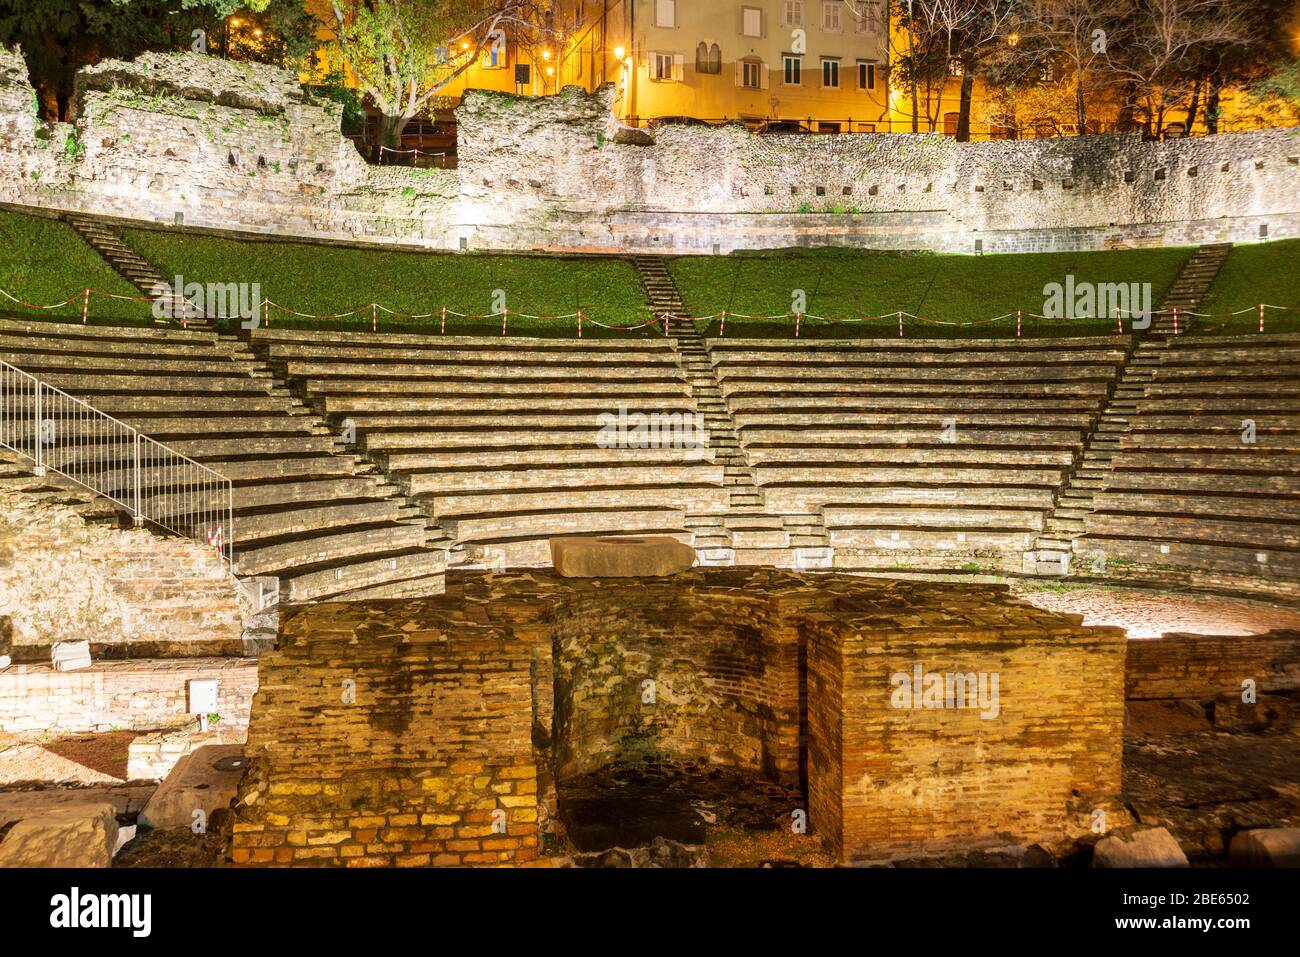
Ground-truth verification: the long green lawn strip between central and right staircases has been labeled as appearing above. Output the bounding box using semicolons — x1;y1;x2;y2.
670;248;1192;338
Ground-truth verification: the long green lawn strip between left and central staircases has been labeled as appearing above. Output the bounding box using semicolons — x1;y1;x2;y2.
125;229;647;337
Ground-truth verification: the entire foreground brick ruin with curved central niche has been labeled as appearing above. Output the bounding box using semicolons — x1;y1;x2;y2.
233;568;1125;866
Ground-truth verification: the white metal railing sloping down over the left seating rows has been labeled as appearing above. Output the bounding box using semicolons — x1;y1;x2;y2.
0;360;235;573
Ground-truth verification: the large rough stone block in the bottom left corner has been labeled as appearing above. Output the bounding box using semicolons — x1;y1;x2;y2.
0;804;117;867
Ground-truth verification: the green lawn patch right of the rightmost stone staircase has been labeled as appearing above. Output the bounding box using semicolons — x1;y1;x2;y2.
1192;239;1300;335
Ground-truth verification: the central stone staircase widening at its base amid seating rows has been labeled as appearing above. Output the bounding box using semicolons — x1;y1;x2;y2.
632;256;829;567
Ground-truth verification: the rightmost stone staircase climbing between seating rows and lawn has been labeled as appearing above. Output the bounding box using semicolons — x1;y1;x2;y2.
1028;243;1231;576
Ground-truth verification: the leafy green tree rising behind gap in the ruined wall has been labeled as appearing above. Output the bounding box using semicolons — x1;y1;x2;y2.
330;0;547;147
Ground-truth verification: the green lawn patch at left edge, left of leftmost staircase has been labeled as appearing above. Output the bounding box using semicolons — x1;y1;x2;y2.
0;209;152;325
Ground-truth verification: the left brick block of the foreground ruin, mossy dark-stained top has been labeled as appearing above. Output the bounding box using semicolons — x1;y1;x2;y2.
233;598;538;867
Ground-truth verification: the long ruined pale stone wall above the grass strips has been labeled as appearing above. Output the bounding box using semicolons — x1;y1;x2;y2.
0;51;1300;252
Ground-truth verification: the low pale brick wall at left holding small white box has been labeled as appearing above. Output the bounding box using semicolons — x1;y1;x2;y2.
0;658;257;735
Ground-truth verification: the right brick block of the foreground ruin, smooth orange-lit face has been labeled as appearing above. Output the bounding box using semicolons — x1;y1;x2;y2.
809;586;1125;861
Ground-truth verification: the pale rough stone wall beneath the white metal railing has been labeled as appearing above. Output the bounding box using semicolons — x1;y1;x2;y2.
0;490;243;662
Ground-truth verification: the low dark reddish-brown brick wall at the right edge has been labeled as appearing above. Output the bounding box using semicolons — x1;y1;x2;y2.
1125;631;1300;700
